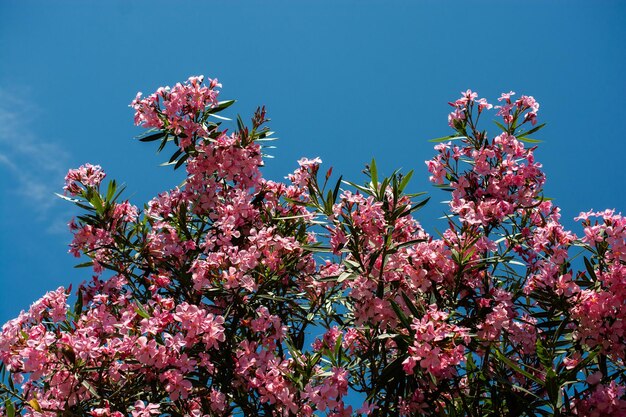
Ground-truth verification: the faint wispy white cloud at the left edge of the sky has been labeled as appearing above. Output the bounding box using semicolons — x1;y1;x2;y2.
0;87;69;233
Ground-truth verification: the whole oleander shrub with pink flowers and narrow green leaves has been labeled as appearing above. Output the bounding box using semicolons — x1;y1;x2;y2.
0;77;626;417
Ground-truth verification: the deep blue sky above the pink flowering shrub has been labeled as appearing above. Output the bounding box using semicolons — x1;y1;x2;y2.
0;0;626;323
